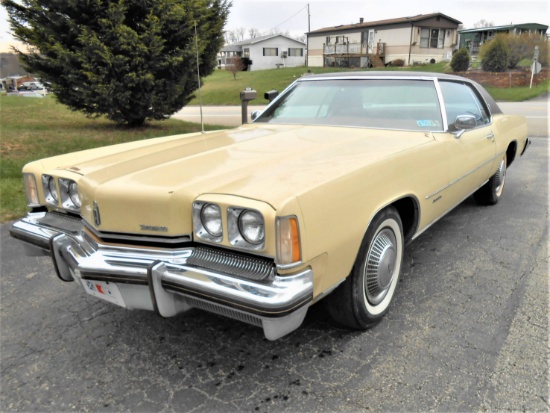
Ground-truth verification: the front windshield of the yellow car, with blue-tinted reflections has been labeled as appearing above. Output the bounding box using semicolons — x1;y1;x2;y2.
256;79;443;131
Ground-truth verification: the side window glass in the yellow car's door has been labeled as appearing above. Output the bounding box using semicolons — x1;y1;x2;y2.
439;81;491;130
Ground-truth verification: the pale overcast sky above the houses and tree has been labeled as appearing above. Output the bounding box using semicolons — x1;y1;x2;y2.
0;0;550;41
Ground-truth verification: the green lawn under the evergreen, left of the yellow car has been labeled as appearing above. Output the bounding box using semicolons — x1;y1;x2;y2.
0;96;227;222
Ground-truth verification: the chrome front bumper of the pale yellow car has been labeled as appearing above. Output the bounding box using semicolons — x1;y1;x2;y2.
10;213;313;340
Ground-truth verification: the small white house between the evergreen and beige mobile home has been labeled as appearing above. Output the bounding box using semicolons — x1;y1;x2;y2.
218;34;306;70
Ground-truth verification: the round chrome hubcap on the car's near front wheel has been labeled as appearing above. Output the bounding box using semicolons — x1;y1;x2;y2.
365;229;397;305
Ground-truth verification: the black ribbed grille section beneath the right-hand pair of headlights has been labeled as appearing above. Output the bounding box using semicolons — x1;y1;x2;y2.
187;247;274;281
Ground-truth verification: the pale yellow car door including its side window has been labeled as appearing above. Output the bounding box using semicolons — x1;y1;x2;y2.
436;81;496;203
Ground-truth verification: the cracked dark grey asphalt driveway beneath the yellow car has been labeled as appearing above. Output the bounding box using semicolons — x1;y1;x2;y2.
0;138;550;412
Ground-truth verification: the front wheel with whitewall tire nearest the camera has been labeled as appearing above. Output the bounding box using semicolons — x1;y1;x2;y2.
325;207;404;330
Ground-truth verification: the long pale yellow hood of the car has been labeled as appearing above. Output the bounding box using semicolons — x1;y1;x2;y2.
67;124;432;233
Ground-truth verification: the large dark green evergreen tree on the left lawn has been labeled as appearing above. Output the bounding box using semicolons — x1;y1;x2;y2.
2;0;231;126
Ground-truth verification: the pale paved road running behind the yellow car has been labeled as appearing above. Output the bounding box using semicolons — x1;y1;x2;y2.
173;99;550;137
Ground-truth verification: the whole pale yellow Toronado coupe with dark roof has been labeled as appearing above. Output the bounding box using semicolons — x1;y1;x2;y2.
11;72;529;340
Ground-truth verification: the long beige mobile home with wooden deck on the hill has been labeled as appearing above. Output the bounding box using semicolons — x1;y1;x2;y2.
307;13;461;67
